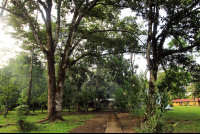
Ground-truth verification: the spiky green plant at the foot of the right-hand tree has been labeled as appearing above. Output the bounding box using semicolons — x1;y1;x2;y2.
138;73;176;133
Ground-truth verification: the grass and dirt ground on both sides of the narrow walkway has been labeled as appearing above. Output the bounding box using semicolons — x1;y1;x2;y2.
0;106;200;133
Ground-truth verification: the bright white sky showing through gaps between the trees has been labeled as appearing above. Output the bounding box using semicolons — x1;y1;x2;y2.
0;9;200;77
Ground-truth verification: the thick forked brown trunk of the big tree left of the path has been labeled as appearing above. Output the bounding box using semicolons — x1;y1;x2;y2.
46;0;65;121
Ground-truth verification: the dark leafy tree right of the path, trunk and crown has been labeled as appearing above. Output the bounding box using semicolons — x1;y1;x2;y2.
125;0;200;115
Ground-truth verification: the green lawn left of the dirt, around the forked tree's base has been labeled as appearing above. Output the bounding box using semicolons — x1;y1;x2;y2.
0;110;94;133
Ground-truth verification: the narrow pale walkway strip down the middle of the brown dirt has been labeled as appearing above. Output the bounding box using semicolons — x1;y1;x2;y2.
105;112;123;133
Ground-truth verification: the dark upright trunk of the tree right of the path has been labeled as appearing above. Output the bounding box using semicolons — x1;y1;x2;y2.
145;0;161;120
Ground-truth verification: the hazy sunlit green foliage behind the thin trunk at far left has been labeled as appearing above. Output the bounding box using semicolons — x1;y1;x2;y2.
0;52;47;109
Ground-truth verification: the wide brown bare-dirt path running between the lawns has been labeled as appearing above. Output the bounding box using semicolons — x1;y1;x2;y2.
70;111;138;133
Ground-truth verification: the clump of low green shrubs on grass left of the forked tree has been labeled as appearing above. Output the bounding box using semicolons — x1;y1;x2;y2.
15;105;37;132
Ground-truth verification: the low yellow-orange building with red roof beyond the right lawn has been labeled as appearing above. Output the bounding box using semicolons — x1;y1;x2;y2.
172;98;200;106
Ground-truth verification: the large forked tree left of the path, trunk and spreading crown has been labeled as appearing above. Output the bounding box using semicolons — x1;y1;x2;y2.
0;0;144;120
